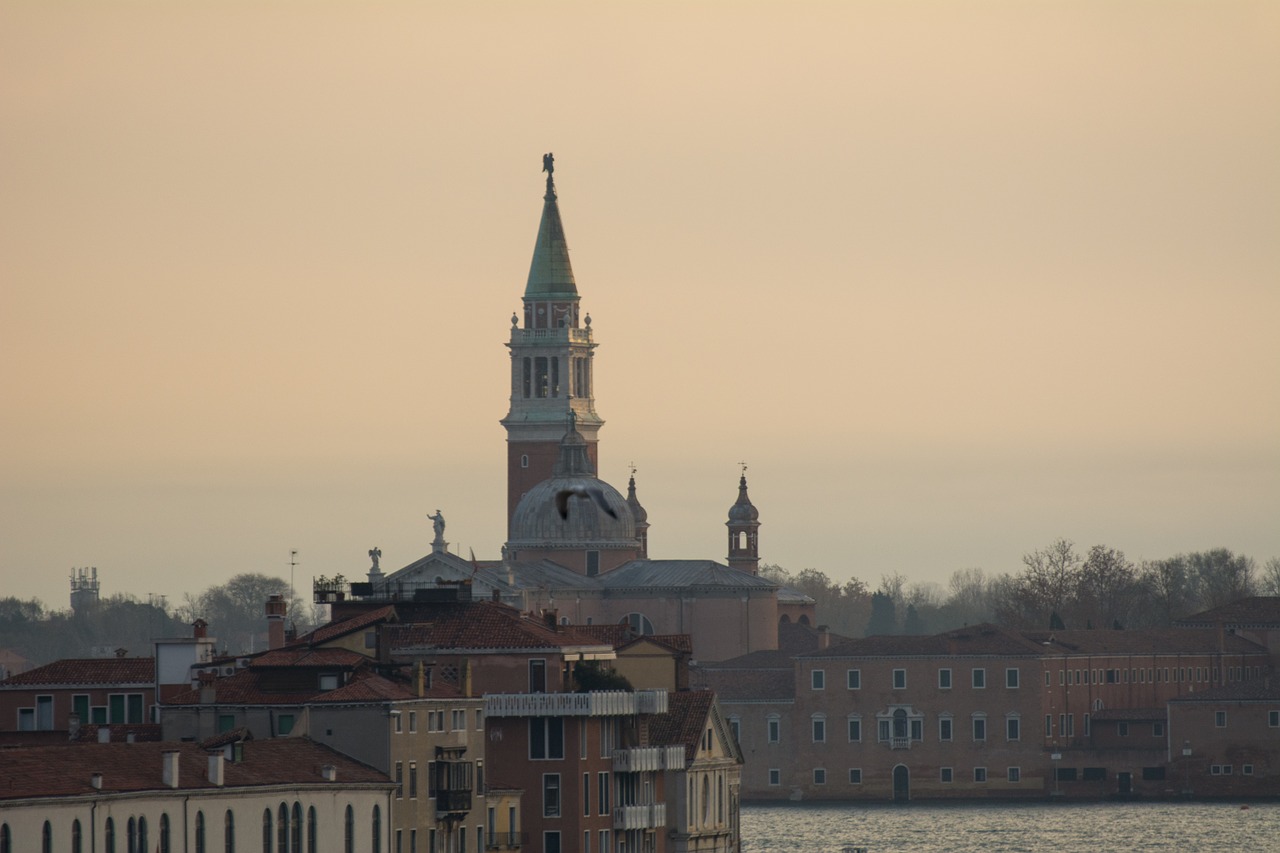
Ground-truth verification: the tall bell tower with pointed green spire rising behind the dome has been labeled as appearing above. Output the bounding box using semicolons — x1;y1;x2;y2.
500;154;604;537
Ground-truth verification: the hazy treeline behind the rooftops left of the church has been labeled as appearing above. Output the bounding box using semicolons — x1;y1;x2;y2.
0;574;324;665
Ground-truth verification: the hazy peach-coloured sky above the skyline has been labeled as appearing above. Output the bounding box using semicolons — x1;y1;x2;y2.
0;0;1280;608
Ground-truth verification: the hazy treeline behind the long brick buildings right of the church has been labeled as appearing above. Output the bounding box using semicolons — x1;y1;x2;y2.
760;539;1280;637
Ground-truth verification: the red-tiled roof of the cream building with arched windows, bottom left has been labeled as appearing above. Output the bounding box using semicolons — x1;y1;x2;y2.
0;738;389;799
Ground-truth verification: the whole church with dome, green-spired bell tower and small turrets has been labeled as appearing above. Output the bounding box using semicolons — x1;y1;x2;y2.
352;161;813;661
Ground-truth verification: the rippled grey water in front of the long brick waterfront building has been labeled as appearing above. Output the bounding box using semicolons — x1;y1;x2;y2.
742;803;1280;853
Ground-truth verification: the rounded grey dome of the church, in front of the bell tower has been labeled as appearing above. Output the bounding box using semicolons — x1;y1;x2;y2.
508;474;636;548
